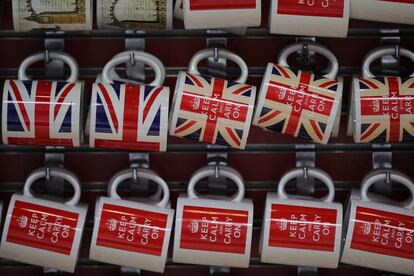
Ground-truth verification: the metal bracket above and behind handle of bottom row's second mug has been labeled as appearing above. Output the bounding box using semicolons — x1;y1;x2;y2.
129;153;150;197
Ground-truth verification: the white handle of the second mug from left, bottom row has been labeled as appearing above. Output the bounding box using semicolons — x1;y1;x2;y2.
108;168;170;208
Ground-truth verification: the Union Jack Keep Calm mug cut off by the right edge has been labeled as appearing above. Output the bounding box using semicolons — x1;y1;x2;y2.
348;47;414;143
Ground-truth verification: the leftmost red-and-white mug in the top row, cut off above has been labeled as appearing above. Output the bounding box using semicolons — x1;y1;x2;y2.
183;0;262;29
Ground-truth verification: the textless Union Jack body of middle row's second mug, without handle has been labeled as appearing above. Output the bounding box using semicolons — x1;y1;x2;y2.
89;83;169;151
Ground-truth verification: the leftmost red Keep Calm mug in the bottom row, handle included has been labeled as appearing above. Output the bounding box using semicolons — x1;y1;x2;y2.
0;168;87;273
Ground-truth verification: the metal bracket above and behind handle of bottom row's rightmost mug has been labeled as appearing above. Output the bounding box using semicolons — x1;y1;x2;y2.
372;144;392;196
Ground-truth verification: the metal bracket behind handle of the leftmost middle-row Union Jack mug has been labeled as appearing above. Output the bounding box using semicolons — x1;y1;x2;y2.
44;31;65;79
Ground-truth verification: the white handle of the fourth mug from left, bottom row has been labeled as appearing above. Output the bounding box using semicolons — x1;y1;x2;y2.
277;168;335;202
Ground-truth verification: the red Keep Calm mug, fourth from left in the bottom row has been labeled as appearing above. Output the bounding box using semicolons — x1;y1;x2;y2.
260;168;342;268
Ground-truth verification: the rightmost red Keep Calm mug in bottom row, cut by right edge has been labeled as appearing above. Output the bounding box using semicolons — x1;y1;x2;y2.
341;170;414;275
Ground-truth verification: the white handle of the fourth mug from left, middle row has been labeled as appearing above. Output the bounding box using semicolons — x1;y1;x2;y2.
277;42;339;79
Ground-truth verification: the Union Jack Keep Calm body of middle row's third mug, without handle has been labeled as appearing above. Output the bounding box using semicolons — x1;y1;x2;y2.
170;73;256;149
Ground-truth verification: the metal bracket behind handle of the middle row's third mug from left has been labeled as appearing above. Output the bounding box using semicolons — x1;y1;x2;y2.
206;30;227;78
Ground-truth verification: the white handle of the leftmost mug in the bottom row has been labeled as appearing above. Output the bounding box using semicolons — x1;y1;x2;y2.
23;168;81;206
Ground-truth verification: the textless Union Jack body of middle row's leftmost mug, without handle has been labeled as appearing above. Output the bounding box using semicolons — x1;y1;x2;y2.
2;80;82;147
